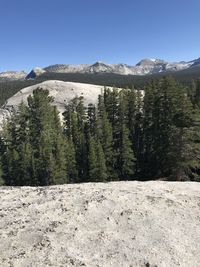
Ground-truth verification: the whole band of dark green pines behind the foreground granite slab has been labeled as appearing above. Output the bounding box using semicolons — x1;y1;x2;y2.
0;77;200;186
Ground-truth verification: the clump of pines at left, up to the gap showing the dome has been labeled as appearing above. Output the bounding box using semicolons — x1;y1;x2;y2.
2;88;68;185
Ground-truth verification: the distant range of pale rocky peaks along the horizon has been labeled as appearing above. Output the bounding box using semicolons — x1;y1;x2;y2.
0;58;200;80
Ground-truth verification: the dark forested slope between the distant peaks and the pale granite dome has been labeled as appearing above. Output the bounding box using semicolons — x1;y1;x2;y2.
0;66;200;106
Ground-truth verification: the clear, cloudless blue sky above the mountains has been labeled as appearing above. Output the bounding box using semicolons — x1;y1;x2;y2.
0;0;200;71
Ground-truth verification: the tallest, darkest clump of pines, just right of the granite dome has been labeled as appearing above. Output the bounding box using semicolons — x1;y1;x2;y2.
143;78;195;180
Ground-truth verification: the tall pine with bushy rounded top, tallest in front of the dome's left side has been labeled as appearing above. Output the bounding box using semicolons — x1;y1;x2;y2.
28;88;55;185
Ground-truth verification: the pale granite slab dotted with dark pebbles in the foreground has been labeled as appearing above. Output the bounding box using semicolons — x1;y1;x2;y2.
0;182;200;267
